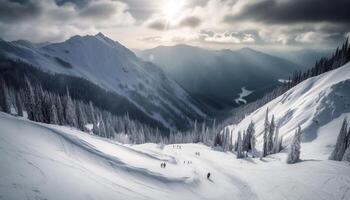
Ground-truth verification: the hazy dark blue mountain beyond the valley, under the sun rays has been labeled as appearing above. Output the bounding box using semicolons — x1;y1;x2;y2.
137;45;303;109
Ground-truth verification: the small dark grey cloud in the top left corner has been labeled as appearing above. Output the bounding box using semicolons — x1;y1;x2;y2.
0;0;42;23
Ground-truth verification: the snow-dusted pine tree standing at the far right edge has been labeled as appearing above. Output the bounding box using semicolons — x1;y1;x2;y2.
329;118;348;161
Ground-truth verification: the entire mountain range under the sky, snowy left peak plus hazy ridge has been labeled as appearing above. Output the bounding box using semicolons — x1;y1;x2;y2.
0;33;330;129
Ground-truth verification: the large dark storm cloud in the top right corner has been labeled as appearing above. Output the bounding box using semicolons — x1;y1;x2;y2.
224;0;350;24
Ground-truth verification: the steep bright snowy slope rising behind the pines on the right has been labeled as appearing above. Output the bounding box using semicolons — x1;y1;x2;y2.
224;63;350;159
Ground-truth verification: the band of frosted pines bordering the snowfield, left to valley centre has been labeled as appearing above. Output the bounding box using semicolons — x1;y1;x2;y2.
0;72;216;145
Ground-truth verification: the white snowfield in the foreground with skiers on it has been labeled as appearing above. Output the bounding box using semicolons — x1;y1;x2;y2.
0;113;350;200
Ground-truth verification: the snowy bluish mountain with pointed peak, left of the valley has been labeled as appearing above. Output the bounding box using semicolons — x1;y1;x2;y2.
0;33;205;128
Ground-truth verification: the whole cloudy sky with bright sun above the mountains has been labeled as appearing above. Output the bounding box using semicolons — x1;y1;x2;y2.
0;0;350;49
